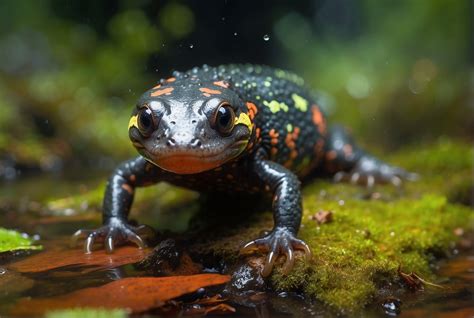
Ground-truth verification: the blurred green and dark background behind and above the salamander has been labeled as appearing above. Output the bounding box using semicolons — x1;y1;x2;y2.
0;0;474;179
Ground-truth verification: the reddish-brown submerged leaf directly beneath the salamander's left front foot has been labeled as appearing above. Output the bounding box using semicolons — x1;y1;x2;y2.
8;246;151;273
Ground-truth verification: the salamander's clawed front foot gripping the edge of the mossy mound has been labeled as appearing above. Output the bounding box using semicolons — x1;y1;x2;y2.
240;228;311;277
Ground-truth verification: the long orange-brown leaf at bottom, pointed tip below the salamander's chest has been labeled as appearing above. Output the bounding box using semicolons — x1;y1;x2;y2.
11;274;230;315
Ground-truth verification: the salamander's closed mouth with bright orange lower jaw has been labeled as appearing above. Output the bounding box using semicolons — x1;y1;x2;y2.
145;140;248;174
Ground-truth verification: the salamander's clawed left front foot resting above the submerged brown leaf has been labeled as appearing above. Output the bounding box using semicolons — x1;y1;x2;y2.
71;220;154;254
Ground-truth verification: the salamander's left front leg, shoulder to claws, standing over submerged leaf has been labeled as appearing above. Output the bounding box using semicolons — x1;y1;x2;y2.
72;157;159;253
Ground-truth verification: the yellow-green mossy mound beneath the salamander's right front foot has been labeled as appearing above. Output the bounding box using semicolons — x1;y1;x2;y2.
187;140;474;312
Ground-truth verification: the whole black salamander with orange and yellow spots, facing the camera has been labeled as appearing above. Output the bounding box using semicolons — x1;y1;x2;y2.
74;65;415;276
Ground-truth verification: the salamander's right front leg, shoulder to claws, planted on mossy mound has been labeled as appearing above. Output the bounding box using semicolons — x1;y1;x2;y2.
241;153;311;277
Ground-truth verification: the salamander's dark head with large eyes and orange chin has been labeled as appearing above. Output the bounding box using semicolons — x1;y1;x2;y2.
129;78;253;174
